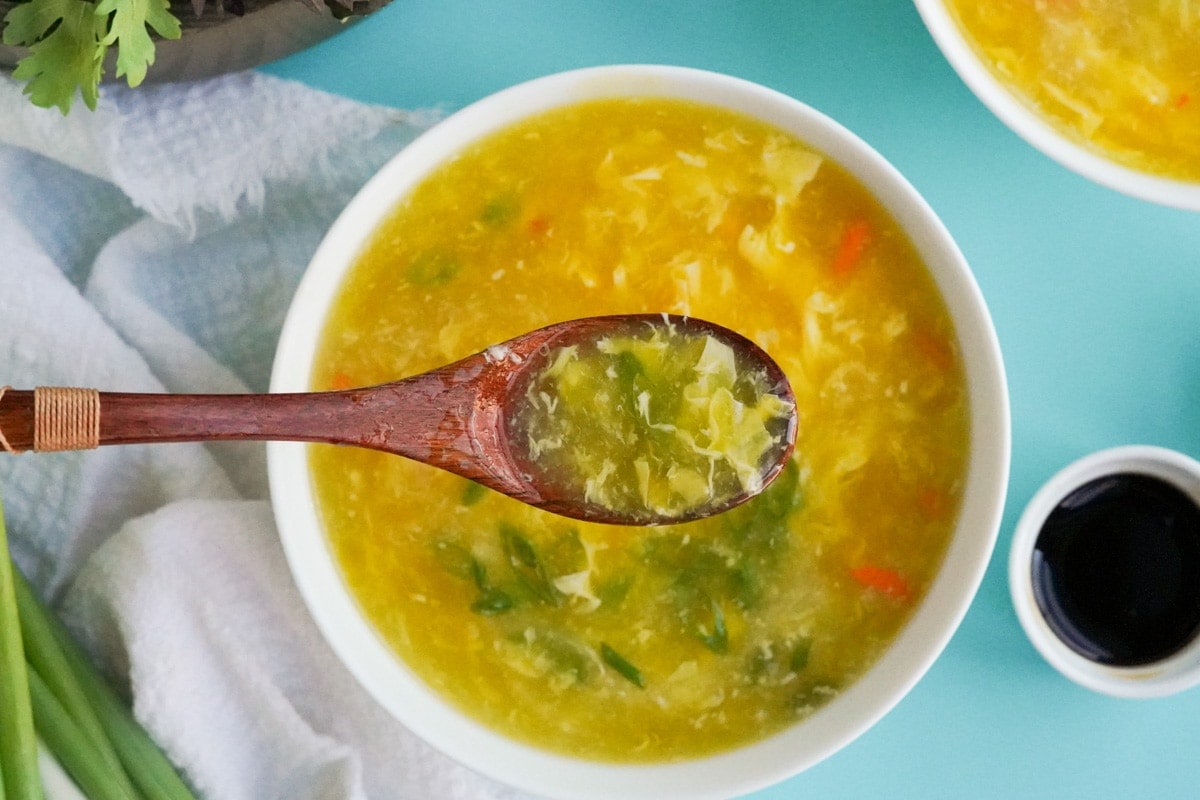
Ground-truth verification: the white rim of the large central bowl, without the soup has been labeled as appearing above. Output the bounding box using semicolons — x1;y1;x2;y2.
268;66;1009;800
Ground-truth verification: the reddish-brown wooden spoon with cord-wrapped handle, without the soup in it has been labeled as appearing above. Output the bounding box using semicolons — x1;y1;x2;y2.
0;314;797;525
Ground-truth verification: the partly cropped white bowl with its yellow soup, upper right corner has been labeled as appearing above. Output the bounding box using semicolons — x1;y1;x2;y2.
916;0;1200;210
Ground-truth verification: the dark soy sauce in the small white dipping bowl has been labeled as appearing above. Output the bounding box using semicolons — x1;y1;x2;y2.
1033;474;1200;667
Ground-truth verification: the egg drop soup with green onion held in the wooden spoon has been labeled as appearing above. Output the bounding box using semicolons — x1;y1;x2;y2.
510;317;794;522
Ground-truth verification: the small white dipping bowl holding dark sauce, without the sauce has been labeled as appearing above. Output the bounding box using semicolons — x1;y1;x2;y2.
1008;445;1200;698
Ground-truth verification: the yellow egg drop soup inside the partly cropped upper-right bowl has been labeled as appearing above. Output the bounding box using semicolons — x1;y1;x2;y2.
947;0;1200;181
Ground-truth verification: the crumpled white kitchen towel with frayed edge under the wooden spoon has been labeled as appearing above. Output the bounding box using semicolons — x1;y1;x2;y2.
0;73;525;800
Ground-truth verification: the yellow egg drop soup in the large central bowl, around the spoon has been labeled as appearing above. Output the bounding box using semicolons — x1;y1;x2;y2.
310;98;968;762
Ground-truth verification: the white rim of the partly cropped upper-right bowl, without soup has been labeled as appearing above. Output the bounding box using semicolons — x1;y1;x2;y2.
914;0;1200;211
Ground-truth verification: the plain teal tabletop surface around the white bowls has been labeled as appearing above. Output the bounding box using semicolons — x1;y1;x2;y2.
265;0;1200;800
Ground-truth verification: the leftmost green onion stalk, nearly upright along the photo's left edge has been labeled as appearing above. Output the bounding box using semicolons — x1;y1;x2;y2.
0;509;42;800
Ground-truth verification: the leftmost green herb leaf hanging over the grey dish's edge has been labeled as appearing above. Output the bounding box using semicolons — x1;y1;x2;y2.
4;0;107;114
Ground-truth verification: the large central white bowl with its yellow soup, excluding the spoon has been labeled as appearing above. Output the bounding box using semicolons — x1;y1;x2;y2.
269;66;1009;799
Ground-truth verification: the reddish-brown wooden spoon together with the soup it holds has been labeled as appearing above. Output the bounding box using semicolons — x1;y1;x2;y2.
0;314;797;525
